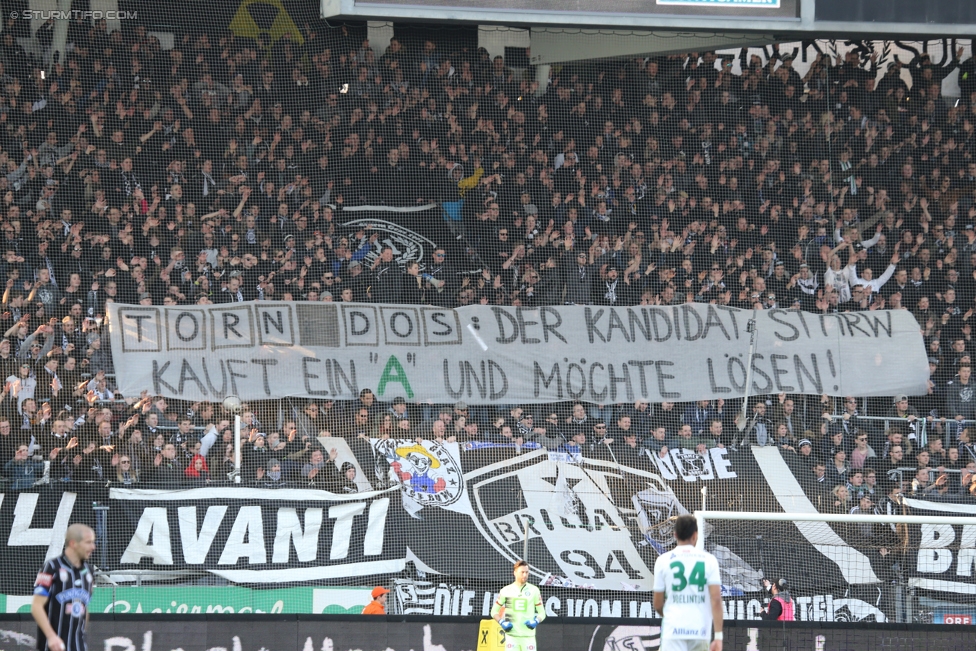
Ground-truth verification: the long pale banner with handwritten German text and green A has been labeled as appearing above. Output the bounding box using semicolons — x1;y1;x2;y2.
109;301;928;404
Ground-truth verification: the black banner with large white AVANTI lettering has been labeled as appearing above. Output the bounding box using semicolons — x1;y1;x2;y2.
109;486;408;585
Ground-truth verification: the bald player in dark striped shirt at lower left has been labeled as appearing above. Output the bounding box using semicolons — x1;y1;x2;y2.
31;523;95;651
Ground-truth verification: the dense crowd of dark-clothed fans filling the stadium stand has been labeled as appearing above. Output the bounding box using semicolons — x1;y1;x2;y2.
0;22;976;512
